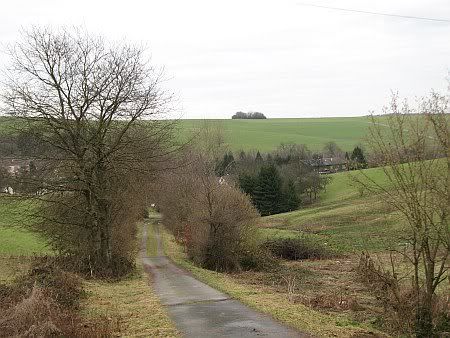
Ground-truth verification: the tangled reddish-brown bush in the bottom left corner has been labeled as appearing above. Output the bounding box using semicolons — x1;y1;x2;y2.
0;259;114;337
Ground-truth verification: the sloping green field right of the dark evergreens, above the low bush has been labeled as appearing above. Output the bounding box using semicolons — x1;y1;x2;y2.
263;168;402;252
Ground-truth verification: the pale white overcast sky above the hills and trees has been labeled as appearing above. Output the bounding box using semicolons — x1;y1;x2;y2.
0;0;450;118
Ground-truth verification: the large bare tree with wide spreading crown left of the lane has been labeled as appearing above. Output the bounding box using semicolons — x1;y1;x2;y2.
3;27;176;274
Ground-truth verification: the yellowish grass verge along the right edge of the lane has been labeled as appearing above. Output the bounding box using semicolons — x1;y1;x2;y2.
161;226;383;337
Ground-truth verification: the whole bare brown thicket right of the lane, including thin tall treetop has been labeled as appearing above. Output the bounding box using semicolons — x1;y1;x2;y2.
158;127;264;271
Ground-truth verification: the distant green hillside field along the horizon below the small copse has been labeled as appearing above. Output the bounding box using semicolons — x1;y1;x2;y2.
179;117;370;151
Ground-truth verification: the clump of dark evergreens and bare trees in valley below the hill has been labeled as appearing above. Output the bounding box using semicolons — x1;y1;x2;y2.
216;144;329;216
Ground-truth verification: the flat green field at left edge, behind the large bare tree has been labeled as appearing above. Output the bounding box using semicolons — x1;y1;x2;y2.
0;197;50;256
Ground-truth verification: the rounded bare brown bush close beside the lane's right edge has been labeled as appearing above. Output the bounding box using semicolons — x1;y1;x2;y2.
188;179;261;271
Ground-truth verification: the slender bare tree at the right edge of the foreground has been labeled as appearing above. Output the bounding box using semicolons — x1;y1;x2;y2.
355;93;450;337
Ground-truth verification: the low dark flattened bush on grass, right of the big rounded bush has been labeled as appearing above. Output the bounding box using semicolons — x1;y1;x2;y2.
263;236;333;260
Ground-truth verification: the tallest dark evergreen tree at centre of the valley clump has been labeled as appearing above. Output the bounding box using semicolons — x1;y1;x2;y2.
253;164;283;216
